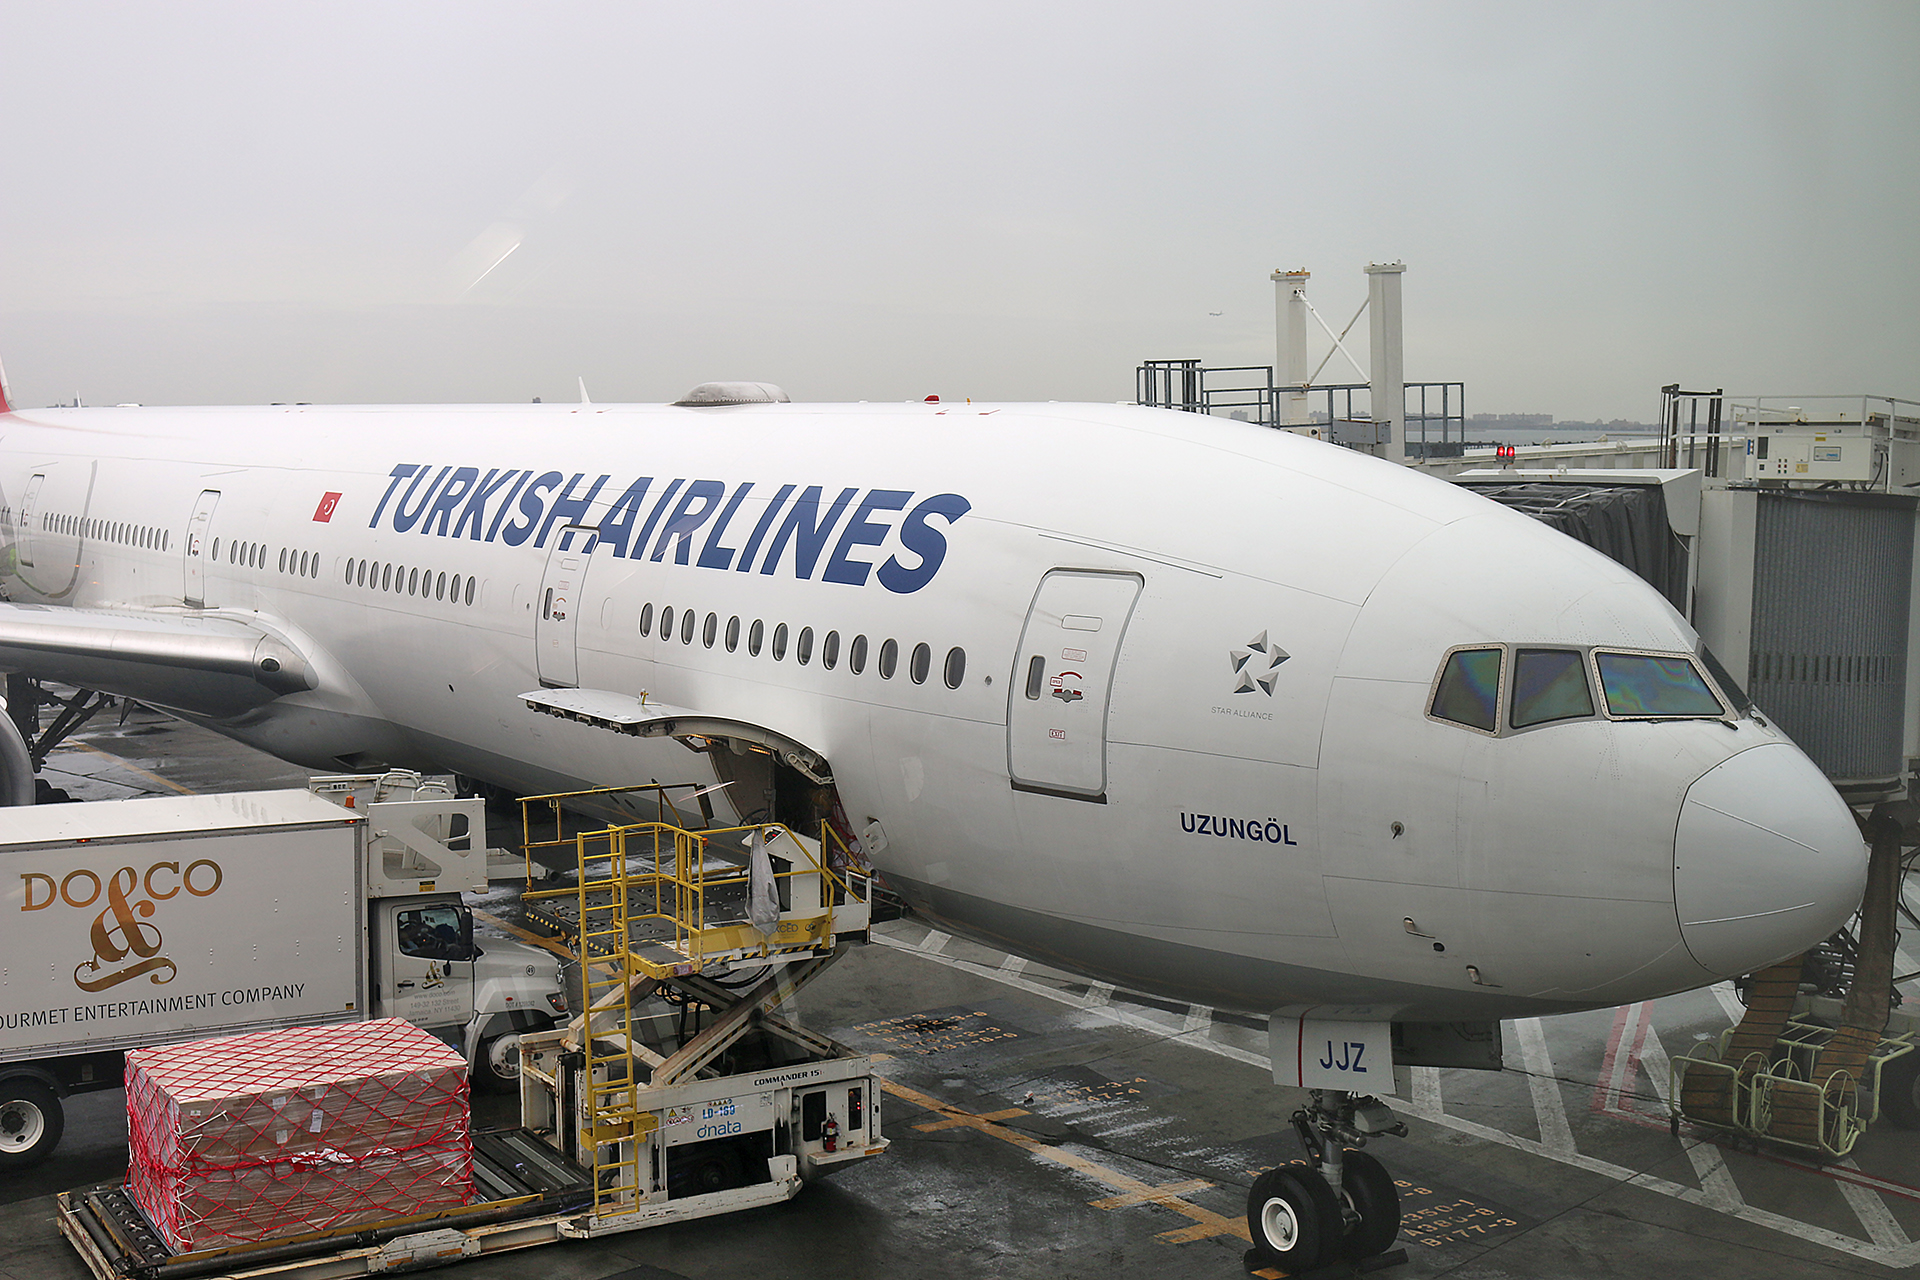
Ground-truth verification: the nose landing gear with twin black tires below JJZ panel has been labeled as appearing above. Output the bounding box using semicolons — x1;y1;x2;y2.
1246;1088;1407;1276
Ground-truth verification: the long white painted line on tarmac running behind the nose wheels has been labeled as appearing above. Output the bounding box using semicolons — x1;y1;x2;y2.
874;929;1920;1268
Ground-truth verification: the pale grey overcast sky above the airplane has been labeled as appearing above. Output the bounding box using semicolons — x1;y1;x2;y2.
0;0;1920;420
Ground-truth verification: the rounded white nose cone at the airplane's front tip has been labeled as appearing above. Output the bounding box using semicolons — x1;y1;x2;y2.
1674;743;1866;977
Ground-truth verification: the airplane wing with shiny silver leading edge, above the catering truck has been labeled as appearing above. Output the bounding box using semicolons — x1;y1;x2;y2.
0;603;315;716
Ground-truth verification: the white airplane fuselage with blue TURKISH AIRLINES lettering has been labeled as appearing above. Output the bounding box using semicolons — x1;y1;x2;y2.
0;403;1866;1021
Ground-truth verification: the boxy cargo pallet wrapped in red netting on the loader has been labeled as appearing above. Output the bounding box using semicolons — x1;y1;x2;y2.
127;1017;472;1253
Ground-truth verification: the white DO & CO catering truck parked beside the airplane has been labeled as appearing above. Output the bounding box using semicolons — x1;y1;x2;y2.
0;773;566;1171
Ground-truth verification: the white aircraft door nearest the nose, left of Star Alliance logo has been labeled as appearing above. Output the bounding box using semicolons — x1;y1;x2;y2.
1006;568;1140;804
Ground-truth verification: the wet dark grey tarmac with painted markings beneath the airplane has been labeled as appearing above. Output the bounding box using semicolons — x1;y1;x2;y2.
0;708;1920;1280
